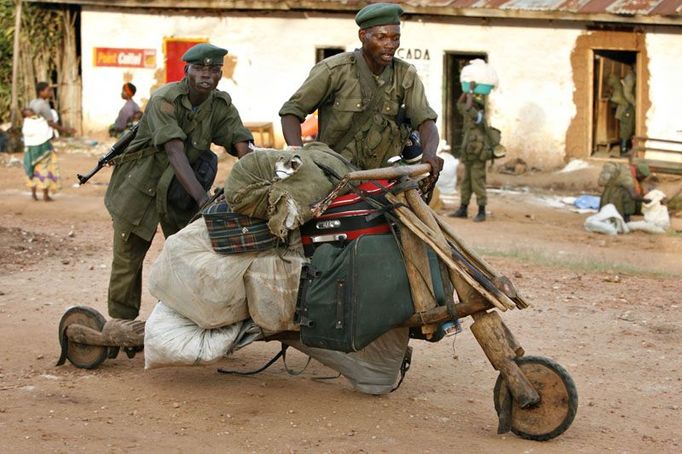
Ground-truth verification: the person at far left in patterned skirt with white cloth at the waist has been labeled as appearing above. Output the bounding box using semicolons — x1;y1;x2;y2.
22;82;75;202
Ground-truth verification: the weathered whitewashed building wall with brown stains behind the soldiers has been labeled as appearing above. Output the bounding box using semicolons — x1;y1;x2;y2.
82;9;682;168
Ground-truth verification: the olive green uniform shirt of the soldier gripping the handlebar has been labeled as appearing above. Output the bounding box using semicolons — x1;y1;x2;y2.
279;50;437;169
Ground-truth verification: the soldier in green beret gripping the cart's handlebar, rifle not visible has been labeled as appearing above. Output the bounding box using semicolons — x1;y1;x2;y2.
279;3;443;181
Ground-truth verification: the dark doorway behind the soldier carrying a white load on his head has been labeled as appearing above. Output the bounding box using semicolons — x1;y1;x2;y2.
442;52;488;156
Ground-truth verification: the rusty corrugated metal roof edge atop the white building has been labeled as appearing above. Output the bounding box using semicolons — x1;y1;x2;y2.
28;0;682;26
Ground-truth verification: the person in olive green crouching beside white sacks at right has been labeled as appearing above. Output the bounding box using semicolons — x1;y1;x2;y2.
599;162;650;222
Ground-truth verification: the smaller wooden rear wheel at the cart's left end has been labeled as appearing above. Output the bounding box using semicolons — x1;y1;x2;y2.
59;306;109;369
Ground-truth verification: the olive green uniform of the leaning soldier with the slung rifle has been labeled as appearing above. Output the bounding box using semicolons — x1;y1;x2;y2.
104;80;253;319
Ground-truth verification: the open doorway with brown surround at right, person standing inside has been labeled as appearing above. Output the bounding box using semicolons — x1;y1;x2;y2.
592;49;638;157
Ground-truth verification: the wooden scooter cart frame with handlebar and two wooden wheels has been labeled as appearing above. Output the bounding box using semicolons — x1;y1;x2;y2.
58;164;578;440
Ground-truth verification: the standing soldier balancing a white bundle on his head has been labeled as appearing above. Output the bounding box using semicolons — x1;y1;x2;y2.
450;82;500;222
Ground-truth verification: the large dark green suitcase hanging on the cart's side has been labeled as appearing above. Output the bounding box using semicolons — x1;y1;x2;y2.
297;235;444;352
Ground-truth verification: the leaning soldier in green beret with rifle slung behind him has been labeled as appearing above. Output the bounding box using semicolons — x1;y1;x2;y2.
104;43;253;320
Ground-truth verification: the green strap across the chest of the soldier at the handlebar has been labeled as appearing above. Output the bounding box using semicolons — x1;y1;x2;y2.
334;49;393;153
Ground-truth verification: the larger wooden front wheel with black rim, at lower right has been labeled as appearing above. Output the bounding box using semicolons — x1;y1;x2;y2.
494;356;578;441
